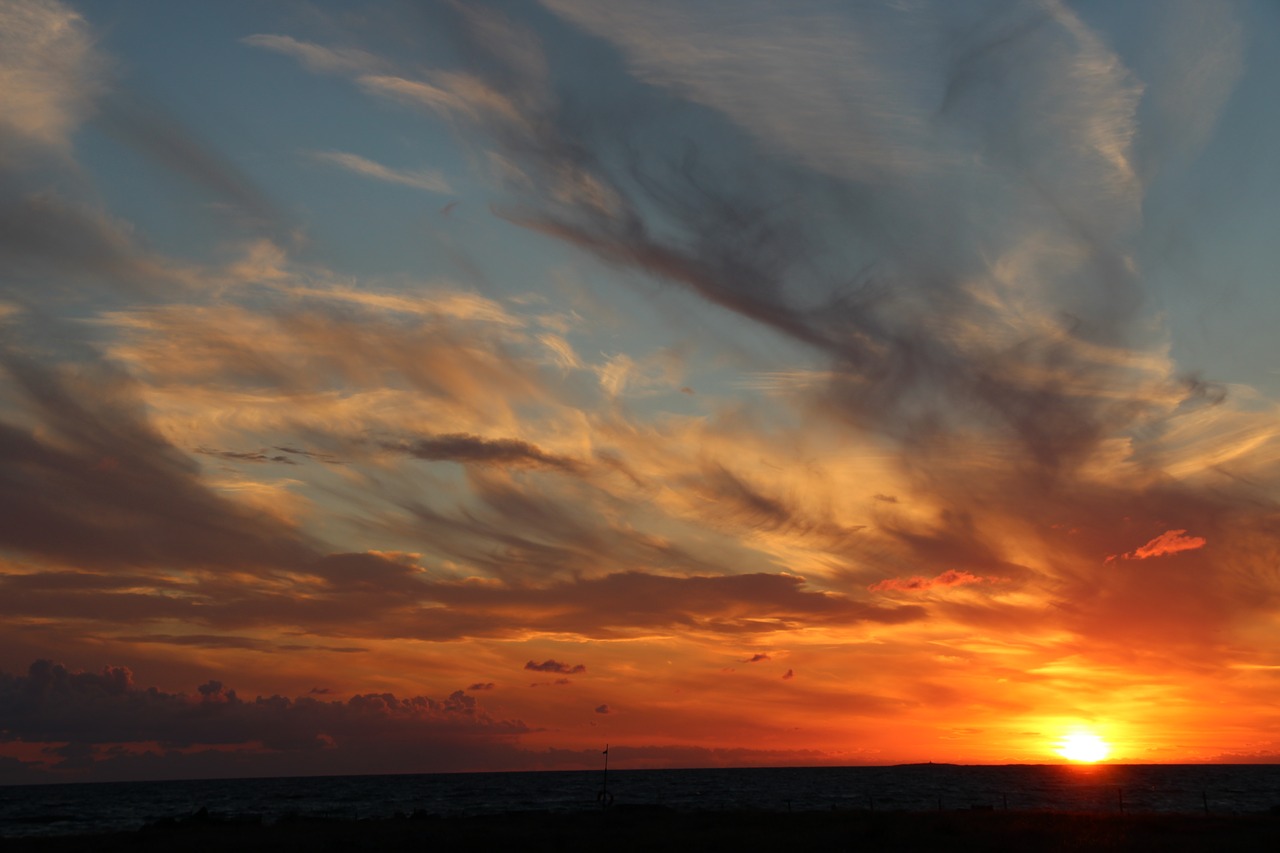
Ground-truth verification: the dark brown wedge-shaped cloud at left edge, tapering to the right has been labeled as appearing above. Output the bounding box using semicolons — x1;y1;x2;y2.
0;351;316;569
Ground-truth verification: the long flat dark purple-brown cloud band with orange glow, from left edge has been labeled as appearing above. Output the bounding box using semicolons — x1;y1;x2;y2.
0;555;928;637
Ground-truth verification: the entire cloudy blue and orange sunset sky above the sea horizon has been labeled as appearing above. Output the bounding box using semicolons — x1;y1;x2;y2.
0;0;1280;783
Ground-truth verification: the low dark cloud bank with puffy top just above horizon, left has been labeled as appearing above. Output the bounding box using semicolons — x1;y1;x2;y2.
0;660;860;784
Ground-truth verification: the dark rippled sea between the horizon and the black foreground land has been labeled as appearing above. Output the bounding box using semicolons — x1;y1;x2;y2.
0;765;1280;836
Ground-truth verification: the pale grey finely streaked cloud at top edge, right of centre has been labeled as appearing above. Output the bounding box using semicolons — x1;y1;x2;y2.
545;0;928;181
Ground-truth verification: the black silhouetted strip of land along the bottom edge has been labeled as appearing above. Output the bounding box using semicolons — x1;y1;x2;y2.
0;808;1280;853
